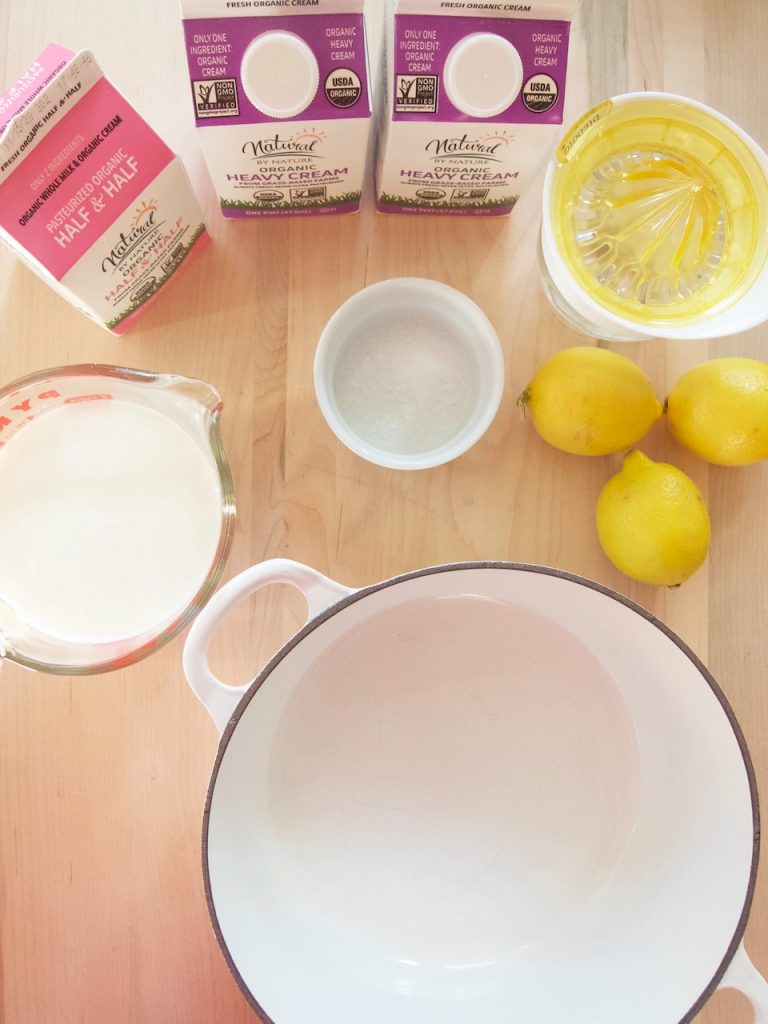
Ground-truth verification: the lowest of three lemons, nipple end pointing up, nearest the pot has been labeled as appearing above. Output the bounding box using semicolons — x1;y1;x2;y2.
596;452;710;587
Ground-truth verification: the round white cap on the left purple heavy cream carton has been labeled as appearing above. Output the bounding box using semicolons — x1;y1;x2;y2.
240;31;319;119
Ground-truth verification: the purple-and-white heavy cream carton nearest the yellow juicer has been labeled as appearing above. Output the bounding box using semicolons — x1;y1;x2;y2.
377;0;579;214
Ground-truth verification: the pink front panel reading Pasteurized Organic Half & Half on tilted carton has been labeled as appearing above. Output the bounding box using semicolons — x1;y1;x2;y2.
0;76;173;281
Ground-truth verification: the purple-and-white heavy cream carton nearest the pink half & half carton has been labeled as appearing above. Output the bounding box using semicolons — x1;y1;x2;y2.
181;0;371;217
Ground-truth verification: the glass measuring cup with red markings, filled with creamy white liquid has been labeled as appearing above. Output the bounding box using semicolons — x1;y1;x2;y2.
0;364;234;675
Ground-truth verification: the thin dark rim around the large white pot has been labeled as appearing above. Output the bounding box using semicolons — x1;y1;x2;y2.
202;561;760;1024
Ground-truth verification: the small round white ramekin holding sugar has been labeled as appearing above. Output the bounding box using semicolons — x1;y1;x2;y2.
314;278;505;469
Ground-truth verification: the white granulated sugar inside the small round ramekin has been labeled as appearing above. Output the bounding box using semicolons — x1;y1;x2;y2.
334;314;477;455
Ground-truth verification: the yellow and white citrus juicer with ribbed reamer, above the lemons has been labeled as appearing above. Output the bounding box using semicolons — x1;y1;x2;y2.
541;92;768;341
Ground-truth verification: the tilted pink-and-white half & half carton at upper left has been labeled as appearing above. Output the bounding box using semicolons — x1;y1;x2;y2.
0;44;208;334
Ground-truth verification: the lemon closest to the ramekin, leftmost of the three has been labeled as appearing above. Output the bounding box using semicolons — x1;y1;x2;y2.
517;345;662;455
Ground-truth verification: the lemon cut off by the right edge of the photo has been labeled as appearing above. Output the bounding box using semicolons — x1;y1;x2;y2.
665;356;768;466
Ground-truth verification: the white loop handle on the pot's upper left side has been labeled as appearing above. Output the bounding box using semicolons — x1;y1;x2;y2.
182;558;352;733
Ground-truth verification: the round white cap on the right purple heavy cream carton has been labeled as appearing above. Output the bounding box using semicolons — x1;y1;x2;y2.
444;32;522;118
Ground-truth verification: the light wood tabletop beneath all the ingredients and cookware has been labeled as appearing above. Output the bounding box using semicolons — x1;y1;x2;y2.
0;0;768;1024
